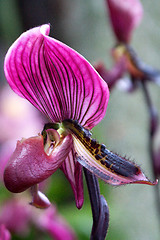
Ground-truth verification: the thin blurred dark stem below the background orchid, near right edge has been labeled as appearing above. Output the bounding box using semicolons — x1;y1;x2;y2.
142;80;160;222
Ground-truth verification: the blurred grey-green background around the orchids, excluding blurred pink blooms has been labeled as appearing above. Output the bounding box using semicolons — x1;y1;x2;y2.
0;0;160;240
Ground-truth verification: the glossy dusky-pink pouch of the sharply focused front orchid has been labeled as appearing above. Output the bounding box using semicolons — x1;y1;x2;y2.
4;135;72;193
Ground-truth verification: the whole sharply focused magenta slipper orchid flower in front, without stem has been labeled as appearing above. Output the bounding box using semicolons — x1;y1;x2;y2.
4;24;155;208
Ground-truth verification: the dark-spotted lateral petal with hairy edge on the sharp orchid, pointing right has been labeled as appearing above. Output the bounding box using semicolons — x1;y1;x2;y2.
73;136;157;185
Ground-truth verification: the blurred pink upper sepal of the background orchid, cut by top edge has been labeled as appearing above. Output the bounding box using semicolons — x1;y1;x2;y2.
106;0;143;43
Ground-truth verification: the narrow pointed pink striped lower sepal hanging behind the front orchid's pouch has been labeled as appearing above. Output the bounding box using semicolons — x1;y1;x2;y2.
60;149;84;209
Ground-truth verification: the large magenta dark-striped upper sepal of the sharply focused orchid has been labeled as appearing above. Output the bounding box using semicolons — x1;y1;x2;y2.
4;24;109;128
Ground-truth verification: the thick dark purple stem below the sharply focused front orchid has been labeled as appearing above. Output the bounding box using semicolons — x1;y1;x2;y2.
83;168;109;240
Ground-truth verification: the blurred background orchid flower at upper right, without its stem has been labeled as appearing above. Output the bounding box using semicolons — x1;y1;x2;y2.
104;0;160;91
